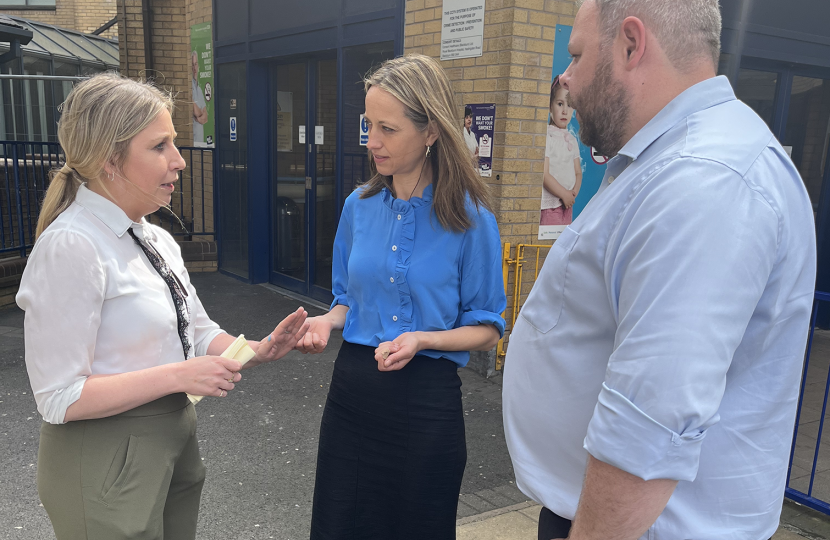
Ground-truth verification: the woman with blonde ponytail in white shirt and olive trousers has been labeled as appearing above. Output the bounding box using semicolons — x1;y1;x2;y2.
17;74;308;540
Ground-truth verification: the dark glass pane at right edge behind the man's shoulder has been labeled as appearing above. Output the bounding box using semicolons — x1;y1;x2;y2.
781;76;830;210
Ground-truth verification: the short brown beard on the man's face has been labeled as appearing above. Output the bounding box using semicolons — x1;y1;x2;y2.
571;55;631;157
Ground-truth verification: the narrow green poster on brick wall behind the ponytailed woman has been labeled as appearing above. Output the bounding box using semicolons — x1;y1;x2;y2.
190;23;216;148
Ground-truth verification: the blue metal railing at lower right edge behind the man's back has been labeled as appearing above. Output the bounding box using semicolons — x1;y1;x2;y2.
785;291;830;514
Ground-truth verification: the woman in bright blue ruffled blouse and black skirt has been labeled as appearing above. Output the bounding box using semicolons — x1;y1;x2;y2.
297;55;505;540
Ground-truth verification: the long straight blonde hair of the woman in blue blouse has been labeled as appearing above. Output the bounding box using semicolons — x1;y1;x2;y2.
361;54;493;232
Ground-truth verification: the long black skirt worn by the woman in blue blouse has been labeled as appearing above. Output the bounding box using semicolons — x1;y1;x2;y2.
311;342;467;540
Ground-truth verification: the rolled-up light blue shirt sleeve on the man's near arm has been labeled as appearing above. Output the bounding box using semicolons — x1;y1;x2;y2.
584;158;779;481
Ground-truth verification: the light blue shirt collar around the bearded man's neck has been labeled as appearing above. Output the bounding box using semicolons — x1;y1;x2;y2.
620;75;736;160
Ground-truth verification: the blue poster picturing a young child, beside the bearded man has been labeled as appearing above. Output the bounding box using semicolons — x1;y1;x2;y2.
538;24;607;240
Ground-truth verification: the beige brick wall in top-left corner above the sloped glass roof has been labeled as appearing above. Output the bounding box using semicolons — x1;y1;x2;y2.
0;0;118;38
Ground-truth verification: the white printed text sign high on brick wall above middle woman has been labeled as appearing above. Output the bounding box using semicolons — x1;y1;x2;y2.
441;0;484;60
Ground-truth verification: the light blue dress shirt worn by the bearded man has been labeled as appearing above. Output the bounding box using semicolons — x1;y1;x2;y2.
504;77;816;540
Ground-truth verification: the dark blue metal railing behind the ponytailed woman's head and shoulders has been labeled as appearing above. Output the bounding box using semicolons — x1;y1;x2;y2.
0;141;216;257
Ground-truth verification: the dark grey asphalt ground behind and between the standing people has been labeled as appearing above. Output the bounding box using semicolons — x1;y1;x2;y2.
0;273;526;540
